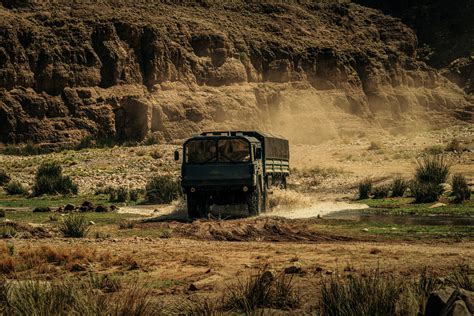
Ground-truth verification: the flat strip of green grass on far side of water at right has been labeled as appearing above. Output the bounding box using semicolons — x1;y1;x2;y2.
358;198;474;216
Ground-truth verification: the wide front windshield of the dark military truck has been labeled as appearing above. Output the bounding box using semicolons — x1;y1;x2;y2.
186;139;250;163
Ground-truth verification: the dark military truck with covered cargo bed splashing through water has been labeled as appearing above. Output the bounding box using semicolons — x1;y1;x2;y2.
175;131;290;218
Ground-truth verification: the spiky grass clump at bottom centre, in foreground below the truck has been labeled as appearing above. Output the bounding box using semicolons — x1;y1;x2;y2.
224;267;300;313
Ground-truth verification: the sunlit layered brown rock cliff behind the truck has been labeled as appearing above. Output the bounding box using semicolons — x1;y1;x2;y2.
0;1;472;143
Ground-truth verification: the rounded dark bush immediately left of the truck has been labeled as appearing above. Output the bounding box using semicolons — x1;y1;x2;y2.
145;174;181;203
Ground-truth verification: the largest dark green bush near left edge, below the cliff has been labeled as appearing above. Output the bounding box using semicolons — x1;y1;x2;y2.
33;162;78;196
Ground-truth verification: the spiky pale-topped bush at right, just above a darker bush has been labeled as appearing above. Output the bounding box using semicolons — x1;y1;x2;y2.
415;156;451;184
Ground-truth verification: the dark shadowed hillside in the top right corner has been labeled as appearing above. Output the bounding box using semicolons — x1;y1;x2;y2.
353;0;474;94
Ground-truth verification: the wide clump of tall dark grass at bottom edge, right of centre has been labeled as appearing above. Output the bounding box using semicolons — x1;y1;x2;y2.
319;271;401;315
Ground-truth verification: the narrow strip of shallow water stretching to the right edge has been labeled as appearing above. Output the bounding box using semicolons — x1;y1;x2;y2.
324;210;474;226
